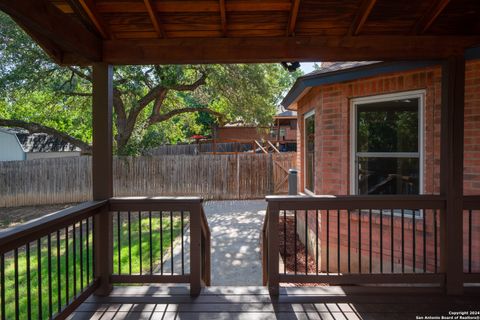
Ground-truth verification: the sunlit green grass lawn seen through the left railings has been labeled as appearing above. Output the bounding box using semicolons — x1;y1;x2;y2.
0;213;184;319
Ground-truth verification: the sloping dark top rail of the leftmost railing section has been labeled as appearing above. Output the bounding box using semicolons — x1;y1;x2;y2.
0;200;108;254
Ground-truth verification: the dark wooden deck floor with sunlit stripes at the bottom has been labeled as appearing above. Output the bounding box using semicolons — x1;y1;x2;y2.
70;286;480;320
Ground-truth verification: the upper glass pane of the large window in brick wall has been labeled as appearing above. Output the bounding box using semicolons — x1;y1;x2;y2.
357;98;419;152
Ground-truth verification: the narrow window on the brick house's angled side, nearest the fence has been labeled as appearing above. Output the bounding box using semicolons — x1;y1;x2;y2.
304;111;315;192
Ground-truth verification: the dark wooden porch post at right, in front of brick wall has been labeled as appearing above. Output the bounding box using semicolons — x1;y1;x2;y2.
440;55;465;295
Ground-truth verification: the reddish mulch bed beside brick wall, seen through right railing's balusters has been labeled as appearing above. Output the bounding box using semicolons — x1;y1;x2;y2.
278;217;327;287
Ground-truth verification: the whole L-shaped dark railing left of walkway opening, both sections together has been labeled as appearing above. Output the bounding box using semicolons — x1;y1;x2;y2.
0;197;211;319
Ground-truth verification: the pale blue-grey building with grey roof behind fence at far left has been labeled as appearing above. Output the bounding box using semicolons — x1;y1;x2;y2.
0;128;81;161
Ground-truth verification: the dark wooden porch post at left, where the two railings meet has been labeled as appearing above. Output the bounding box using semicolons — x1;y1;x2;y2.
92;63;113;295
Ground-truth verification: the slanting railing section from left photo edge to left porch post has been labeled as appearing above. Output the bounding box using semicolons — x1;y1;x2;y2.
0;201;108;320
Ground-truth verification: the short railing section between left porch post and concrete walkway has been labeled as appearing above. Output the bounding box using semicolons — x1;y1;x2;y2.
110;197;210;295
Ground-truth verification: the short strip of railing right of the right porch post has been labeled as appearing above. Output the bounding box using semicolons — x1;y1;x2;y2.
463;196;480;283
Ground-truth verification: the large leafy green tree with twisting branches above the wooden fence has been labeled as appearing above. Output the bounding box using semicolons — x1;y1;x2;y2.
0;13;299;154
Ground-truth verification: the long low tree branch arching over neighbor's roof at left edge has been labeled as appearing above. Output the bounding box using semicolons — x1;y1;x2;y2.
0;119;92;154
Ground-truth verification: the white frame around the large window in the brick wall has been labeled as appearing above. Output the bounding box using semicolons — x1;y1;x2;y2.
350;90;425;195
